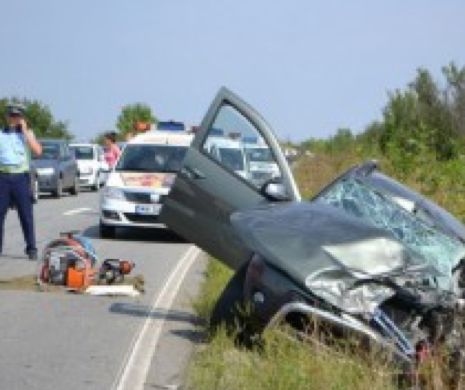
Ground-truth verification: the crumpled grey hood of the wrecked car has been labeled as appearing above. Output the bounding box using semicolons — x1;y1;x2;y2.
231;202;452;314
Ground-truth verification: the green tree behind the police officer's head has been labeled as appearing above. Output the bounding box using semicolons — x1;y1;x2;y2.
0;97;73;140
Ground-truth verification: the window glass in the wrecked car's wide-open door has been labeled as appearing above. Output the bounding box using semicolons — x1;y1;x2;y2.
202;104;282;190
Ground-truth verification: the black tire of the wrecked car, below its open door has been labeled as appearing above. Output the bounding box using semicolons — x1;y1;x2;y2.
210;262;261;347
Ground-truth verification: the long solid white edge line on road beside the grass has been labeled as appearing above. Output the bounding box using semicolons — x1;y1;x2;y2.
112;246;200;390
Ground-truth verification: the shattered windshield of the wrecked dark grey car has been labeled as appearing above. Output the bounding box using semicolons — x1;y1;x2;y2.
316;178;465;287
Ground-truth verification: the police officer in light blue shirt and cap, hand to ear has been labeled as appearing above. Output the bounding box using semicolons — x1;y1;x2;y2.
0;104;42;260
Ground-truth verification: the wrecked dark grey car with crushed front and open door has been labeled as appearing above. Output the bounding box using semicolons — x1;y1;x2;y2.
160;88;465;362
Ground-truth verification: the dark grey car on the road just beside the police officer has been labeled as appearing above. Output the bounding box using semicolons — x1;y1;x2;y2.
32;139;79;198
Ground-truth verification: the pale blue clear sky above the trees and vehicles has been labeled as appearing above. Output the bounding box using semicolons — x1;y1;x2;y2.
0;0;465;141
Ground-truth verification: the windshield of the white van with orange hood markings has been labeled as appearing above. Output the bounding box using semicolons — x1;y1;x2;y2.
116;145;187;173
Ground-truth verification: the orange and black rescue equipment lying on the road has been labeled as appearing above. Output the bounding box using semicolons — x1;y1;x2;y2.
38;232;135;291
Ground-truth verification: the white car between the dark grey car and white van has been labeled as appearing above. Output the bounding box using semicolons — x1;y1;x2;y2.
69;144;110;191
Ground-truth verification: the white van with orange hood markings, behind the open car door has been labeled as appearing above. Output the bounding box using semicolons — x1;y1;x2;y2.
100;130;193;238
